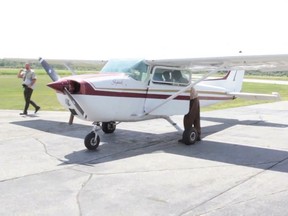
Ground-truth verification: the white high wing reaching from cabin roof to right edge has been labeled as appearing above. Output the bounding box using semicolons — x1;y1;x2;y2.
147;54;288;72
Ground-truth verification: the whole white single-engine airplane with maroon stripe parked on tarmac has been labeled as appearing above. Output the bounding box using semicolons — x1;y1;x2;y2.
39;54;288;150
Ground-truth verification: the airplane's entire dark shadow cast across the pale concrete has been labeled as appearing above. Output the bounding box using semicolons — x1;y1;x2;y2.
12;117;288;172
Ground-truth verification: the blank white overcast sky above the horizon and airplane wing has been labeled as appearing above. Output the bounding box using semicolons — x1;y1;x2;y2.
0;0;288;60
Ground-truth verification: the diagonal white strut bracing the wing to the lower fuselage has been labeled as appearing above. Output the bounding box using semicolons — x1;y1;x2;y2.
141;67;224;116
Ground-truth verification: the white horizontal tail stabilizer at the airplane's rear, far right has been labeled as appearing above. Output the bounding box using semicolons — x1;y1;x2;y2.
227;92;281;100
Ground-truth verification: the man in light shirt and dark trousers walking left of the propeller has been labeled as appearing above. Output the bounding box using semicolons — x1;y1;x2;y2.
17;63;40;115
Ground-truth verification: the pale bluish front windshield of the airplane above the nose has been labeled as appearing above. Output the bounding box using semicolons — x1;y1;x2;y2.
100;59;148;81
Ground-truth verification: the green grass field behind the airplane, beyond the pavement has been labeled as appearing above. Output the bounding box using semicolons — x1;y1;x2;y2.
0;73;288;111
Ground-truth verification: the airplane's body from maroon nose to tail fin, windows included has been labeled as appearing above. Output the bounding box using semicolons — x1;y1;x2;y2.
48;60;244;122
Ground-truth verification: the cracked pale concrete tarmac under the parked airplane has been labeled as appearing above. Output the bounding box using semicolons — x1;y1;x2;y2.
0;101;288;216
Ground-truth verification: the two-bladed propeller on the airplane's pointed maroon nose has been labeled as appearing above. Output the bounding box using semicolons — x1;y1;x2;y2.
39;57;87;124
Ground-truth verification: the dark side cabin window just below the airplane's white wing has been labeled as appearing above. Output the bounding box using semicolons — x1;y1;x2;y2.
152;68;190;86
